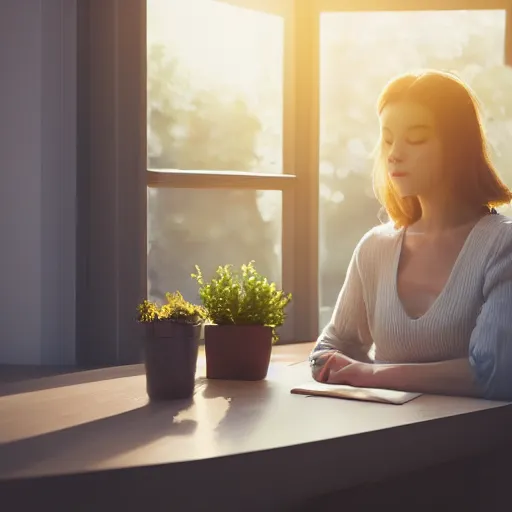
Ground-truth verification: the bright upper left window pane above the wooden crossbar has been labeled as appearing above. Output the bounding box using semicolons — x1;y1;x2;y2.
147;0;284;173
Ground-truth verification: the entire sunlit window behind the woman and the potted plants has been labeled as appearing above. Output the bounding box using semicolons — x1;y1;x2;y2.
147;0;512;339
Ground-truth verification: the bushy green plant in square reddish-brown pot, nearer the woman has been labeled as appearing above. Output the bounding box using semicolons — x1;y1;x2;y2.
192;261;291;380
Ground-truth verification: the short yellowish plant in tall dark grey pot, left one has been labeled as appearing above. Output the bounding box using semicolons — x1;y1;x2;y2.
137;292;205;400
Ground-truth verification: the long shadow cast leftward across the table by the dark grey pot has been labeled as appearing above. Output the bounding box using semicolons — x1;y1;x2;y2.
0;399;197;477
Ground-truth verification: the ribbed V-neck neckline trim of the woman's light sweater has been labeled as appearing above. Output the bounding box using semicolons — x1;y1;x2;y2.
393;215;492;322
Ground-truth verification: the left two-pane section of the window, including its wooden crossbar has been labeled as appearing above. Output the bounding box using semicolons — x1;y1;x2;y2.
147;0;317;342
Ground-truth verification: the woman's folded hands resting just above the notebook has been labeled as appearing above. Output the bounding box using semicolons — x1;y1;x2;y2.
313;350;374;387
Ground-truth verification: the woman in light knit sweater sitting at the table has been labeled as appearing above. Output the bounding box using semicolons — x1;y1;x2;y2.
310;71;512;400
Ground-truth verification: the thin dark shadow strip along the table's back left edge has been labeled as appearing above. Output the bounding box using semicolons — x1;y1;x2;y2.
0;364;144;397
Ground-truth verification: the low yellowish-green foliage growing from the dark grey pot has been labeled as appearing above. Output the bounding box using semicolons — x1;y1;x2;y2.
137;292;206;324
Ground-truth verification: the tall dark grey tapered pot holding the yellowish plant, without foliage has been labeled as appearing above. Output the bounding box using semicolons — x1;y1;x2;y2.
144;321;201;400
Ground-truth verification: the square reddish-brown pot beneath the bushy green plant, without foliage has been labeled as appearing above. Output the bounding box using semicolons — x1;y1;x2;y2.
204;325;272;380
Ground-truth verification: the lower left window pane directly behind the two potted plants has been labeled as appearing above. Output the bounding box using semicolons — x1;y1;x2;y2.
148;188;282;301
